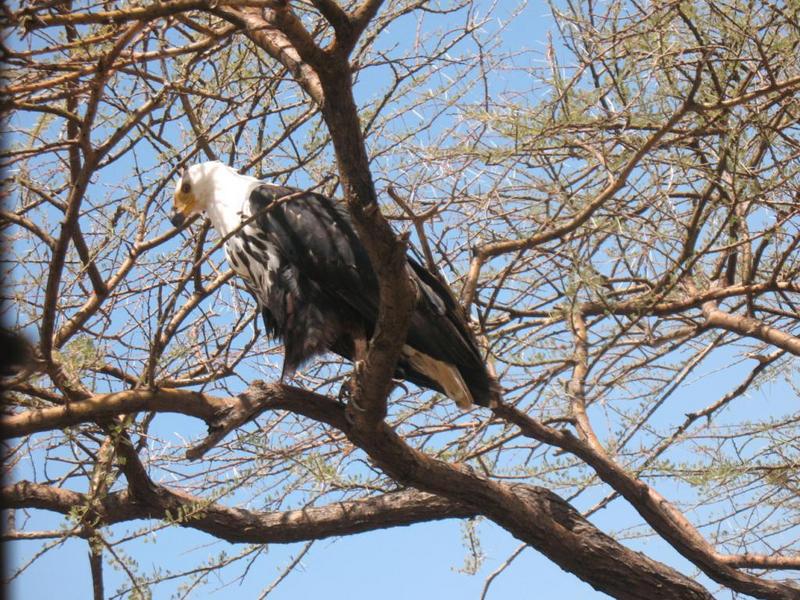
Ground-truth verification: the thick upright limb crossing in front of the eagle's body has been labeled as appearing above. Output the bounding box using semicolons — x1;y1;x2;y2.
219;1;416;423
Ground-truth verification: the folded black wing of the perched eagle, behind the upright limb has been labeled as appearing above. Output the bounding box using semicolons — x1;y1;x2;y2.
250;184;496;404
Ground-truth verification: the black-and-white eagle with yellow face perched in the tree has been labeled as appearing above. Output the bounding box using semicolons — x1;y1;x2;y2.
170;161;499;409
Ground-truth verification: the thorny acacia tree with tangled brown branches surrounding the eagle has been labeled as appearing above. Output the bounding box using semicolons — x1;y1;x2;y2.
2;0;800;598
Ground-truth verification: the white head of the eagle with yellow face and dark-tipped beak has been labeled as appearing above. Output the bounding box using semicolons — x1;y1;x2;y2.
170;160;257;235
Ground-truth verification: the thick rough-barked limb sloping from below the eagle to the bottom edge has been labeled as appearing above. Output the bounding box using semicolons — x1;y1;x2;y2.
248;384;712;600
